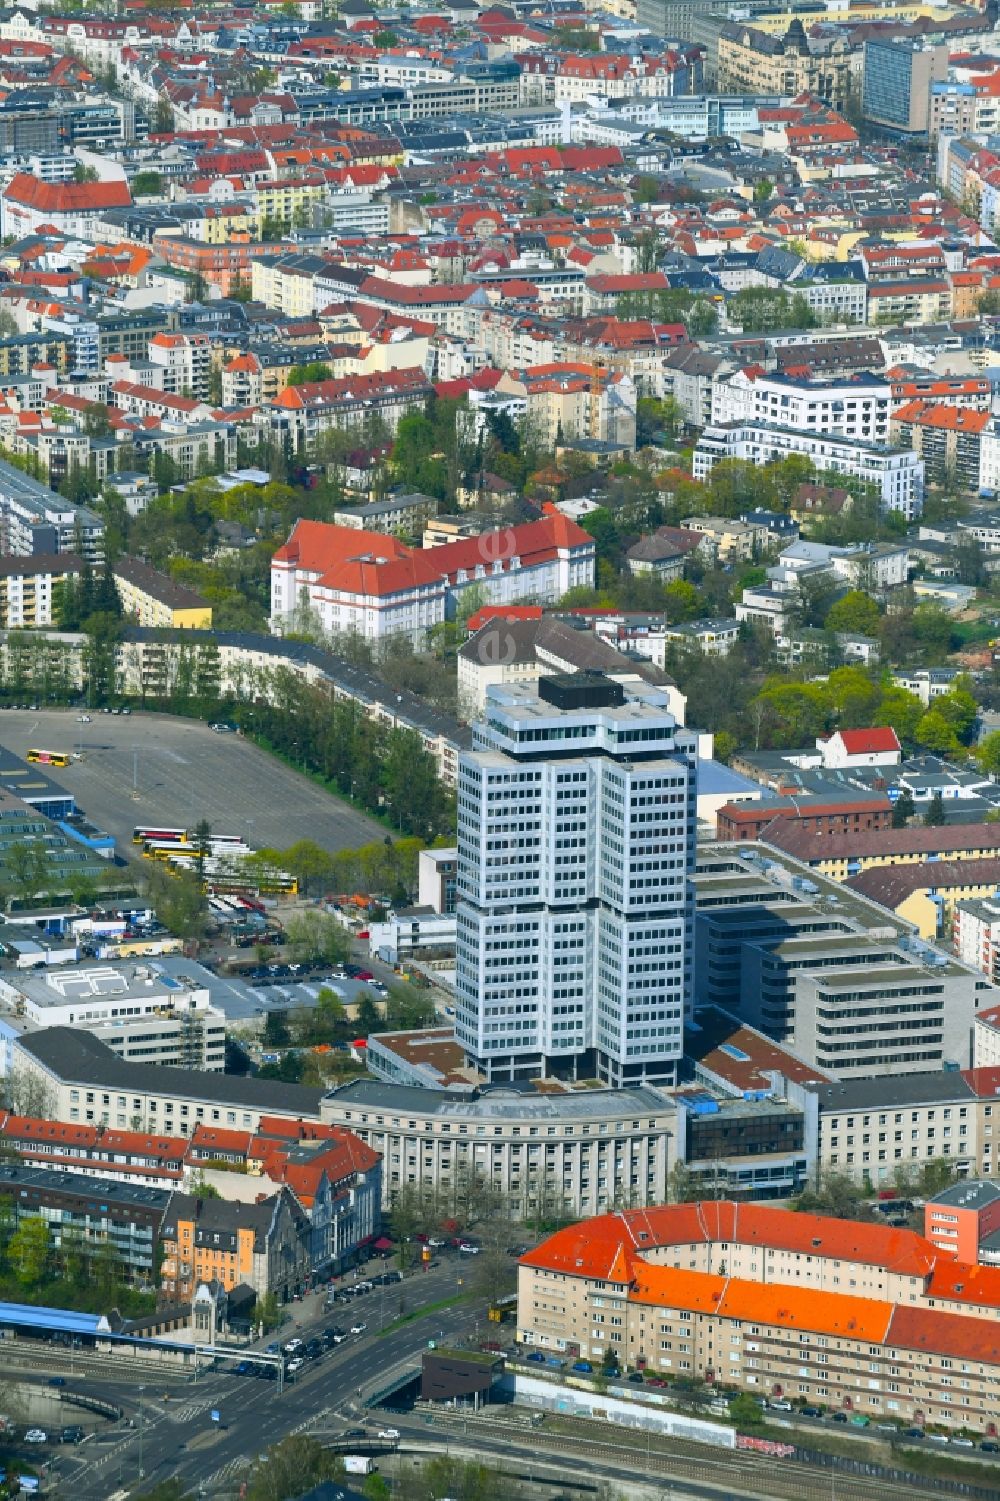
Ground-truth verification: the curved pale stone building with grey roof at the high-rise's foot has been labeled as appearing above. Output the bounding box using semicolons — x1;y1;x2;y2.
316;1079;676;1219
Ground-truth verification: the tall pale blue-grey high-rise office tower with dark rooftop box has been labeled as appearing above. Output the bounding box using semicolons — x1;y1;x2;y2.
455;672;697;1085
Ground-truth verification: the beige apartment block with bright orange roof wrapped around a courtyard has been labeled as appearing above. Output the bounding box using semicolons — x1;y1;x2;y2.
518;1202;1000;1432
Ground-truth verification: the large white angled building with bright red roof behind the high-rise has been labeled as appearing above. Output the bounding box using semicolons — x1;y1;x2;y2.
270;515;595;644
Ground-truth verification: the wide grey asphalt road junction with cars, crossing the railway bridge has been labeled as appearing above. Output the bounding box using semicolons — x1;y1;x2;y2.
32;1258;486;1501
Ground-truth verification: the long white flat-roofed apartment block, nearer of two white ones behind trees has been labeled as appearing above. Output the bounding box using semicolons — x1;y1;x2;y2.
692;414;923;521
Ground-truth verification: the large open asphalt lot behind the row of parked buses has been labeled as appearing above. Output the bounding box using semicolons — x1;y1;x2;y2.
0;708;386;854
